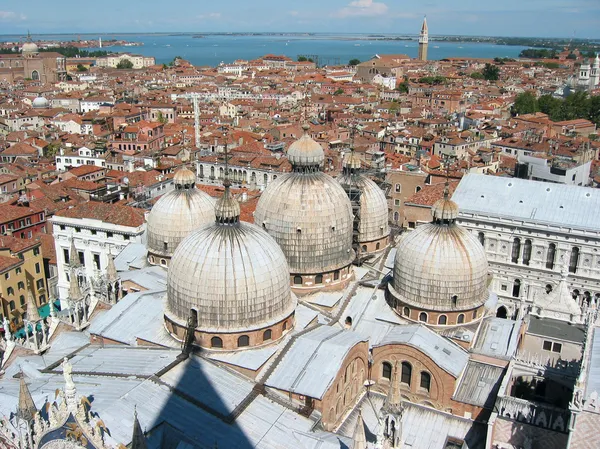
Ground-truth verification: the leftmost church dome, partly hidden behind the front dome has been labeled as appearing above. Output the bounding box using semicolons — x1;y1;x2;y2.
146;169;215;265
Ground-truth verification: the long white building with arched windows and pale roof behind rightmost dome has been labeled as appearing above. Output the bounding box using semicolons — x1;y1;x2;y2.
452;174;600;315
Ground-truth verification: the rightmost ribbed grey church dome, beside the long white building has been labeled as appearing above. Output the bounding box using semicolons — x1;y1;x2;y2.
390;194;488;312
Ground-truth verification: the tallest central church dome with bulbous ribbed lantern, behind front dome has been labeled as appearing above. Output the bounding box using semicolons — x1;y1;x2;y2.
254;126;354;292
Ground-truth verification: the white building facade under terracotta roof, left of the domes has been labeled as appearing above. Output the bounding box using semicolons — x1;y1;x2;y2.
49;215;145;301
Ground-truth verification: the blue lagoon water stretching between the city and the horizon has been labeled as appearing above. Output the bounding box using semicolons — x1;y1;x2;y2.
0;33;528;66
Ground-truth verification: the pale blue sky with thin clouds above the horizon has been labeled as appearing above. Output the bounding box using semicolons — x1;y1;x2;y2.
0;0;600;38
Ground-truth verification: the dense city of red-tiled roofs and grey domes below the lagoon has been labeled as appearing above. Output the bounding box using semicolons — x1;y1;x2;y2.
0;1;600;449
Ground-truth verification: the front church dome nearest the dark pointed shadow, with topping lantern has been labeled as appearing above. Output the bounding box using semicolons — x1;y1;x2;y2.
167;188;296;336
